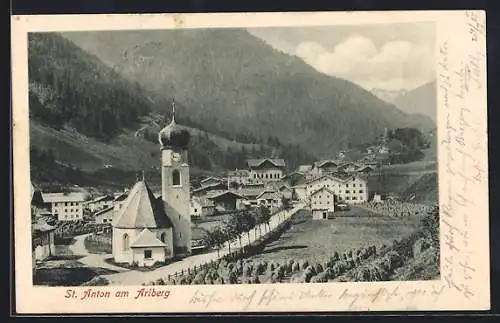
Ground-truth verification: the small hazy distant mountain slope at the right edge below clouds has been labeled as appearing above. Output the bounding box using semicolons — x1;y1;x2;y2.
394;81;437;121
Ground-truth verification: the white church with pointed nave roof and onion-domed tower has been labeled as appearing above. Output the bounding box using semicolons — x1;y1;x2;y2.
112;103;191;267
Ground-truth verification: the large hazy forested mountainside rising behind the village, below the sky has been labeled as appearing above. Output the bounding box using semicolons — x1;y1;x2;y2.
63;29;434;156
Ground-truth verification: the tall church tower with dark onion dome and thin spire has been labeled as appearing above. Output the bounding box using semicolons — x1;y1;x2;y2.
158;101;191;256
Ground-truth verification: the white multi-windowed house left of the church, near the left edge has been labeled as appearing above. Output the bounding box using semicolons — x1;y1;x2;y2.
42;193;85;221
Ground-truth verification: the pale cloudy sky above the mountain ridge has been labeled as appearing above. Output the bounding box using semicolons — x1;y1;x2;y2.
249;23;436;90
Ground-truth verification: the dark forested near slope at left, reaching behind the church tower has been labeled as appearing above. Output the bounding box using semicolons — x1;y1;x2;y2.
29;34;312;185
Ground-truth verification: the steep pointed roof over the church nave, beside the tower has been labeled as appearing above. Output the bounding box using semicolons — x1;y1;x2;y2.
113;181;172;229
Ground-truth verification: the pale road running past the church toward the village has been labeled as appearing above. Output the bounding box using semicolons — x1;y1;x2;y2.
70;203;304;285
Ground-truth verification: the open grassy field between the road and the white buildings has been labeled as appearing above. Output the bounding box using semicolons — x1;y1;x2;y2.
250;209;421;261
